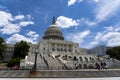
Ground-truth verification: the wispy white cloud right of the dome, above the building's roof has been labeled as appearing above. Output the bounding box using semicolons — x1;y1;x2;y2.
66;30;90;44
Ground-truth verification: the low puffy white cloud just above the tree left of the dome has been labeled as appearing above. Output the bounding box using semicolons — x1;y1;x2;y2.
6;31;39;44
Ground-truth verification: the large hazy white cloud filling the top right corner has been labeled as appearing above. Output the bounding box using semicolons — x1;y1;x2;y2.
94;0;120;22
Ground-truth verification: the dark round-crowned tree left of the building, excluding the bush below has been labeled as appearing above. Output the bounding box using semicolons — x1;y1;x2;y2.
14;41;30;58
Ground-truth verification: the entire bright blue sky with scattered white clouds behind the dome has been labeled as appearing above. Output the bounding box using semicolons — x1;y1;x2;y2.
0;0;120;48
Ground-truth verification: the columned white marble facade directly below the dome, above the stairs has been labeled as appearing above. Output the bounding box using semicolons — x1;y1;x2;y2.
38;39;96;61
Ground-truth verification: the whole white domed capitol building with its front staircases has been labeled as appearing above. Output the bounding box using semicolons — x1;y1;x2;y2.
20;17;104;70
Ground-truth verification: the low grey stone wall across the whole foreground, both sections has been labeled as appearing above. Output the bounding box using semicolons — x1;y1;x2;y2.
0;69;120;78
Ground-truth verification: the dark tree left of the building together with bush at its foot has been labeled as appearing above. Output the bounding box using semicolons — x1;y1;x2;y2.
7;41;30;67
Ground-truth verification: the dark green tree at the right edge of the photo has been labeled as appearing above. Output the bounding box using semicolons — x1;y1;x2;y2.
106;46;120;60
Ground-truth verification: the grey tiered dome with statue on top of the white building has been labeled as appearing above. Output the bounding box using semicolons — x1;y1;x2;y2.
43;17;64;40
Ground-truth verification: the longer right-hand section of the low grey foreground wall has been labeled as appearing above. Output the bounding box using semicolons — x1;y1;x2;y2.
30;69;120;78
